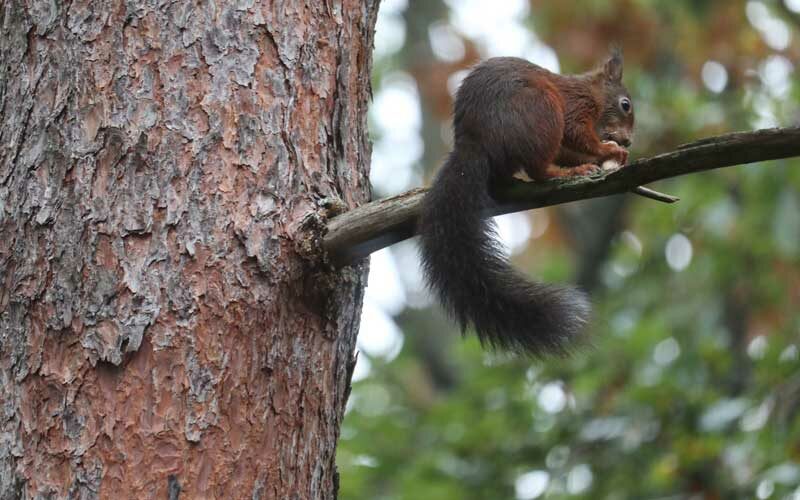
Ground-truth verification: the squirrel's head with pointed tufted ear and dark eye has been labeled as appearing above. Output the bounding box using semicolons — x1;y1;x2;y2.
592;47;633;148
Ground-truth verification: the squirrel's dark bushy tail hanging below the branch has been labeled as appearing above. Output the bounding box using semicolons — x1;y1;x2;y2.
419;146;590;357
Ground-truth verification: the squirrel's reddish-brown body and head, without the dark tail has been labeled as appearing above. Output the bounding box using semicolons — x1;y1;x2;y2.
454;55;633;180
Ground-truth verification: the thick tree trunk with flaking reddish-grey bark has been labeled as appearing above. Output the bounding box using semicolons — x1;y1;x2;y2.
0;0;378;499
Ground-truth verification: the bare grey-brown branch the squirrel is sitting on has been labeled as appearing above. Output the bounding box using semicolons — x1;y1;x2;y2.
323;127;800;265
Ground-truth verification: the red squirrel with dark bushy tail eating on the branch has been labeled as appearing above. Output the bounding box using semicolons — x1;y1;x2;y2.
418;49;634;357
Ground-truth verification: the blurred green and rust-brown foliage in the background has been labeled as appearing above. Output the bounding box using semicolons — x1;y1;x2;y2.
337;0;800;499
